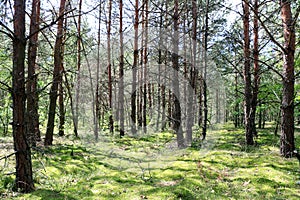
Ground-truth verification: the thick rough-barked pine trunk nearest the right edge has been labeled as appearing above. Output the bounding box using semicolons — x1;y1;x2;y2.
280;0;296;157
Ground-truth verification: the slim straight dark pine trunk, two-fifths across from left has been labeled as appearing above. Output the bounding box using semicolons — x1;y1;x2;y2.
119;0;124;137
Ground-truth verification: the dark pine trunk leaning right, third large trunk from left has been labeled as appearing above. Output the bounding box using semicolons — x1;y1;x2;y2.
45;0;66;146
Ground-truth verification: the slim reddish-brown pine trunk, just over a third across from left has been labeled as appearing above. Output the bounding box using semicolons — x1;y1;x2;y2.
107;0;114;133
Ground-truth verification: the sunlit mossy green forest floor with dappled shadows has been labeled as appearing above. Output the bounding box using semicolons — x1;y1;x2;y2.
0;125;300;200
